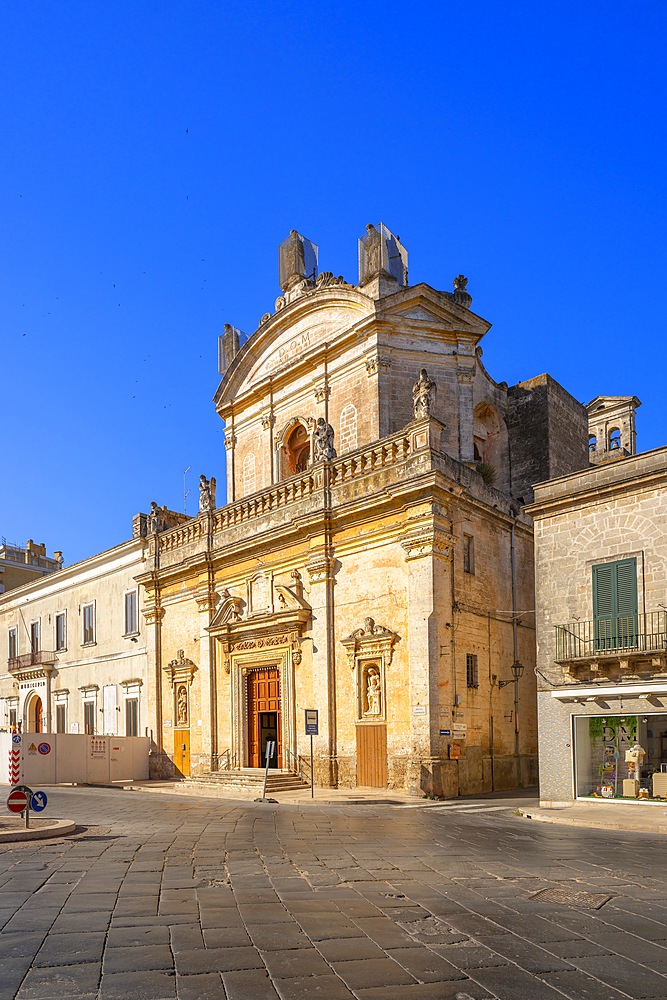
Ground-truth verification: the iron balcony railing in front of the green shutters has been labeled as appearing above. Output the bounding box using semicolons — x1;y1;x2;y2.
556;611;667;660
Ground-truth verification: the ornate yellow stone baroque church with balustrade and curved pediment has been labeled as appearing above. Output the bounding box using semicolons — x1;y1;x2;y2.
135;224;589;796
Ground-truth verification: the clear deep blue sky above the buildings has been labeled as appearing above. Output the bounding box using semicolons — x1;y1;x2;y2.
0;0;667;563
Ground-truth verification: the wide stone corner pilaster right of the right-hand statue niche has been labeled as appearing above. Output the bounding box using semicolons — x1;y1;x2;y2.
401;516;457;795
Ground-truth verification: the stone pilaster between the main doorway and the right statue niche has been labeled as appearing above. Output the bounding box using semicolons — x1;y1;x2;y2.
306;550;338;788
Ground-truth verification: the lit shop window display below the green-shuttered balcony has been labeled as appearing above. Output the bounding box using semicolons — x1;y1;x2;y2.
574;715;667;801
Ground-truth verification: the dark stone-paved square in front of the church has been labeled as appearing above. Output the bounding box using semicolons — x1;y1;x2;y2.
0;789;667;1000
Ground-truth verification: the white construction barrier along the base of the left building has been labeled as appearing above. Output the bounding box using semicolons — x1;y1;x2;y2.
0;733;150;787
